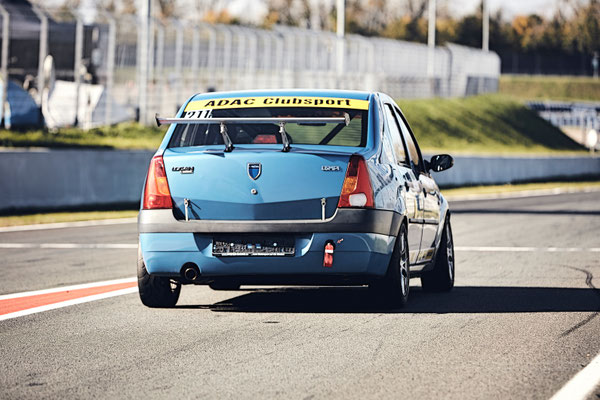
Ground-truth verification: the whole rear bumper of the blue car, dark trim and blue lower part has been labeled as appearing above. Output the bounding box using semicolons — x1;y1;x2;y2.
138;209;402;284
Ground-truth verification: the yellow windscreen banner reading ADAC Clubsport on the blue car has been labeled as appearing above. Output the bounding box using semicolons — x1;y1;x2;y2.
185;96;369;112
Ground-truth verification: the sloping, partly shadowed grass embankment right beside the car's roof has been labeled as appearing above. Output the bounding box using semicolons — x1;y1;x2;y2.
398;95;583;154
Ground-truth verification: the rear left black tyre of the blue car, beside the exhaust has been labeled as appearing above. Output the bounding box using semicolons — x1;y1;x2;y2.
137;245;181;308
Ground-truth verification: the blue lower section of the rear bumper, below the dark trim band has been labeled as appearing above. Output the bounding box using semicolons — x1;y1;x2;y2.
140;232;396;284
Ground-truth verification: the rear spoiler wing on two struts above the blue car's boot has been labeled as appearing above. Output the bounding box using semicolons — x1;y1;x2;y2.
154;113;350;152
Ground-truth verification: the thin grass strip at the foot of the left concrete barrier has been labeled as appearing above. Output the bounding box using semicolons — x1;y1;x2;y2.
0;210;138;226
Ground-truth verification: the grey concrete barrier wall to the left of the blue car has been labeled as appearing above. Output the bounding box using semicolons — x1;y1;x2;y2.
0;149;154;210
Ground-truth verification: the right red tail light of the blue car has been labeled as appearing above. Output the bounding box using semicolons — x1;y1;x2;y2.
338;155;373;208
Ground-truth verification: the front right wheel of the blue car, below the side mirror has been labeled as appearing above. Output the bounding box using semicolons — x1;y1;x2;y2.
421;216;455;292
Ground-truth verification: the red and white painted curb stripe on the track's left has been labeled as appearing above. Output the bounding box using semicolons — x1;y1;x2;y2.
0;278;138;321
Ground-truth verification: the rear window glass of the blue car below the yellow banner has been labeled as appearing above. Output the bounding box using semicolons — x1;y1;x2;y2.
169;106;368;148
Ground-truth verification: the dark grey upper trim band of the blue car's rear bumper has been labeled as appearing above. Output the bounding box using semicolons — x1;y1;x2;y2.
138;208;403;236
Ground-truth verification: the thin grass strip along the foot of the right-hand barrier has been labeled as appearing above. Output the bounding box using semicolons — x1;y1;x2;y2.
442;181;600;198
